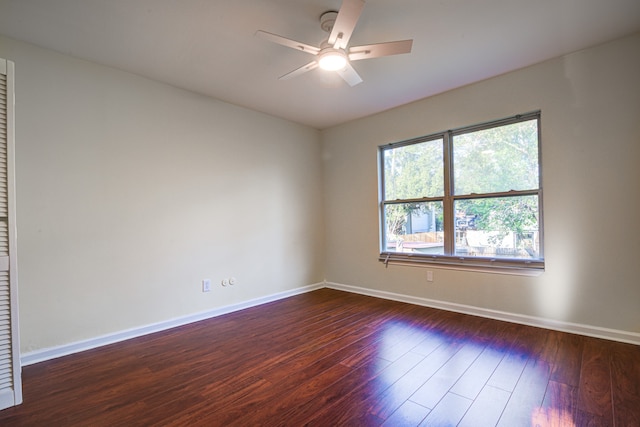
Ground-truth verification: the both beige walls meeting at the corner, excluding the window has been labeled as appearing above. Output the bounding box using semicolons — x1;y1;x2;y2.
0;34;640;352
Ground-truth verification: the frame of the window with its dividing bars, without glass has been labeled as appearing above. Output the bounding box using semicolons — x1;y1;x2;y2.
378;111;545;275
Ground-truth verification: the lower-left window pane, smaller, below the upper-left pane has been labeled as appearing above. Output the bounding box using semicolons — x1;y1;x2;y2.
383;202;444;254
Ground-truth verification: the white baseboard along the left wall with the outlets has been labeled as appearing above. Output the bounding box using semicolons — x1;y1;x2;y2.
20;283;325;366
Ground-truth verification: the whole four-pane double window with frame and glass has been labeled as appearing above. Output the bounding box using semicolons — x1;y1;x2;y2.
379;112;544;271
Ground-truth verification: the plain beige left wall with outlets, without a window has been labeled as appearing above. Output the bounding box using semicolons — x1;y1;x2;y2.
0;38;324;352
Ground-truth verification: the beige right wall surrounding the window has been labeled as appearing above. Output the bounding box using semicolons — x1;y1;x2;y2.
322;34;640;333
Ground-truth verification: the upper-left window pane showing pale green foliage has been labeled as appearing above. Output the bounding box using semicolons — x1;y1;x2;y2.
384;139;444;200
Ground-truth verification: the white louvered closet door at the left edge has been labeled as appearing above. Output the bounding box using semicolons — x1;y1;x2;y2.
0;59;22;409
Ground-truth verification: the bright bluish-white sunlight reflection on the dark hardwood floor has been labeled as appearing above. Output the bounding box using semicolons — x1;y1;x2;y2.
370;318;576;427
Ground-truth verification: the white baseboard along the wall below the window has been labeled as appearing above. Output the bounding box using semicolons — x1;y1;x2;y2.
325;282;640;345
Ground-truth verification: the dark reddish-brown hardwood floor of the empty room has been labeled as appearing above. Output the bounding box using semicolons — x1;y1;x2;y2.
0;289;640;427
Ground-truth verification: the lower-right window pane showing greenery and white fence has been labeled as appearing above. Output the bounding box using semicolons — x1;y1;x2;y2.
455;196;540;259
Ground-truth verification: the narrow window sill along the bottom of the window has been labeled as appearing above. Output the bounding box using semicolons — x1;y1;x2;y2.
378;252;544;276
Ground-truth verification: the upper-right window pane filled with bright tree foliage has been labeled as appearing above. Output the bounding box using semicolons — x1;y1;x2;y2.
453;120;539;195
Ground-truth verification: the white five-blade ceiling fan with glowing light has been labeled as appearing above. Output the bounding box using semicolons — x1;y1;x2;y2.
256;0;413;86
